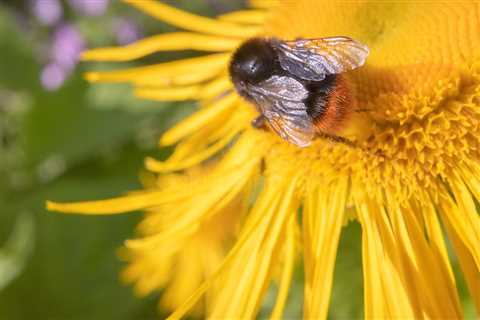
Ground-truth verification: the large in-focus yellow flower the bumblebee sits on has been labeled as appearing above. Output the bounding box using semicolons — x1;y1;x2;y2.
49;0;480;319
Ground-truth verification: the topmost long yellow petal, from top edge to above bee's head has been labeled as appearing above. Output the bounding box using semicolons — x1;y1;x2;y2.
124;0;259;38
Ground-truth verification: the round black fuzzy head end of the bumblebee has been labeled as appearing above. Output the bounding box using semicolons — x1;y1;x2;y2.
229;38;276;87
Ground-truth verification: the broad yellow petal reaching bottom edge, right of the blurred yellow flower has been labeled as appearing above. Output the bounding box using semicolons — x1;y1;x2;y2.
209;176;298;319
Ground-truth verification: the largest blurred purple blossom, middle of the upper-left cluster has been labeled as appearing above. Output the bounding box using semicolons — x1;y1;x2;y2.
50;24;85;71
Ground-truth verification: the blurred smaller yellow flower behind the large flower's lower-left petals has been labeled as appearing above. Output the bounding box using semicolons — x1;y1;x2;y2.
120;168;247;316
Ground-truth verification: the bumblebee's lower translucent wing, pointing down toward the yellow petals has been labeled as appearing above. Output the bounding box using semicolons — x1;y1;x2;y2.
249;76;315;147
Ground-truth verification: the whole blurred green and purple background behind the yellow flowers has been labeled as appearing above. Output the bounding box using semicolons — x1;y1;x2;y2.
0;0;473;320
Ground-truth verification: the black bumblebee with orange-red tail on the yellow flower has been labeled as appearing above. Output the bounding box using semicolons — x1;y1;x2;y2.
229;37;369;147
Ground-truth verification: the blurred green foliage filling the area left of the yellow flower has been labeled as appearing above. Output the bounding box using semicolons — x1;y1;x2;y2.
0;3;183;320
